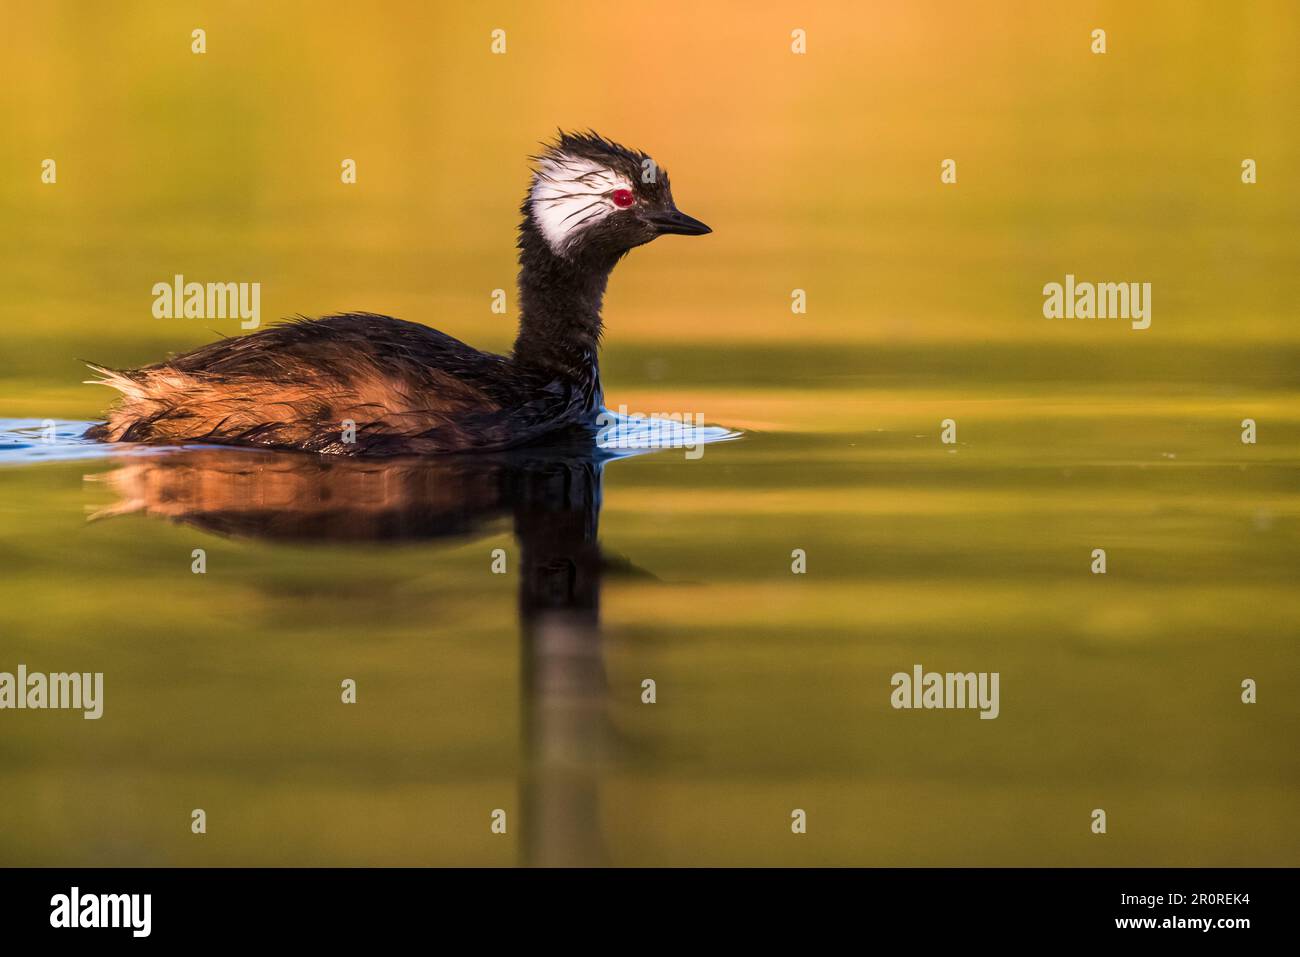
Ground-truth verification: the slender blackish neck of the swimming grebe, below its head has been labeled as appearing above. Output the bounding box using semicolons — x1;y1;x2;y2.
511;217;618;382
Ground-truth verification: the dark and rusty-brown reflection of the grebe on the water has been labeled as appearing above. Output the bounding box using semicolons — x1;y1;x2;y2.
86;446;616;866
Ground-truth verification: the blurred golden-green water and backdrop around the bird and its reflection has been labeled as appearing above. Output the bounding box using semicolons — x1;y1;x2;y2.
0;0;1300;865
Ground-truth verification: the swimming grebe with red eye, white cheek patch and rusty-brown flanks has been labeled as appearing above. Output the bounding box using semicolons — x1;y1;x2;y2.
86;133;711;455
